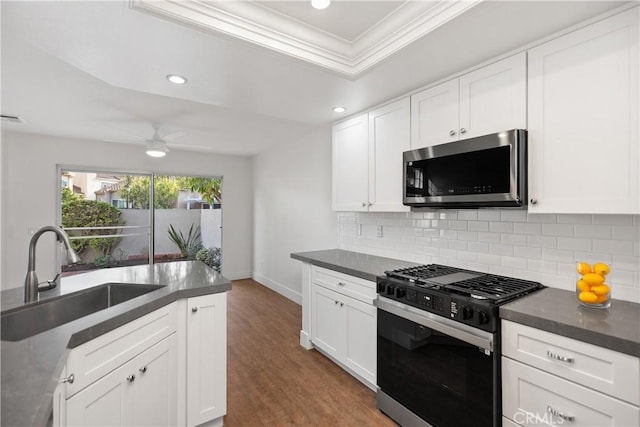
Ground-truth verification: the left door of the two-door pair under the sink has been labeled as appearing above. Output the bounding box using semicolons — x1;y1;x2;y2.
66;363;135;427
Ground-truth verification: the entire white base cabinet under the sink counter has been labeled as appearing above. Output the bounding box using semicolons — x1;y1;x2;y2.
53;292;227;426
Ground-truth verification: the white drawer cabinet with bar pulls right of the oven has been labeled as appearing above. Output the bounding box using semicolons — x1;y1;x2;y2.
502;320;640;426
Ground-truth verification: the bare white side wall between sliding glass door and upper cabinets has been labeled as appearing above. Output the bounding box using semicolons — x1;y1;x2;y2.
252;126;337;304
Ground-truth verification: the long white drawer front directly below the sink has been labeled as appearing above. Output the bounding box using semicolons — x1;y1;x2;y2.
66;302;177;398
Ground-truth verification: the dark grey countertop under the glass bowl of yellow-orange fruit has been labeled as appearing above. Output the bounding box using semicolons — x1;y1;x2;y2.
500;288;640;357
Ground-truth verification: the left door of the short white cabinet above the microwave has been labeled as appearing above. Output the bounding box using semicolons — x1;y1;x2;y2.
411;79;458;149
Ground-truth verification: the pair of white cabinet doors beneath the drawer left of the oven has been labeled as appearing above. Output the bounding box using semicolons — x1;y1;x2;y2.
311;283;376;388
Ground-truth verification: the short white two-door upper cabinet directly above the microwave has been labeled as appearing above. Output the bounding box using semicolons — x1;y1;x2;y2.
411;53;527;149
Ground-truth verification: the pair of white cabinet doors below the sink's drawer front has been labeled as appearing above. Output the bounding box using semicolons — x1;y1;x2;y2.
66;334;177;426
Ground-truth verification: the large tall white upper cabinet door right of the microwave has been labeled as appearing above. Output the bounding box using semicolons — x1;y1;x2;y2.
529;8;640;214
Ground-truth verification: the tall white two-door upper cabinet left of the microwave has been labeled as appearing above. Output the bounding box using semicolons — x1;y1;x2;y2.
333;98;410;212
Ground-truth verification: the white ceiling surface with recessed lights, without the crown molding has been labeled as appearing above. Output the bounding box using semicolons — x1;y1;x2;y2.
0;0;623;155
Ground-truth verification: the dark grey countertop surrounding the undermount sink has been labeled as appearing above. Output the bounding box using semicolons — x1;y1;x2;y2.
0;261;231;426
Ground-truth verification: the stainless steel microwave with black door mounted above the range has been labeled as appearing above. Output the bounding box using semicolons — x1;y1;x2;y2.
403;129;527;208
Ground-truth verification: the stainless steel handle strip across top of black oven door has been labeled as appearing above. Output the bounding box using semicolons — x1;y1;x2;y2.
373;295;493;352
